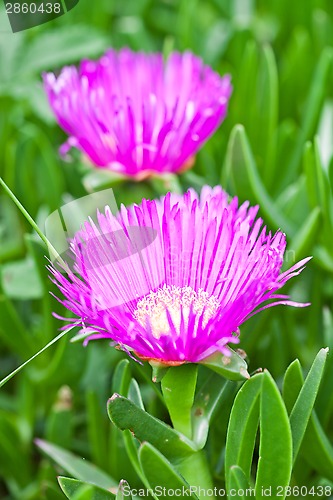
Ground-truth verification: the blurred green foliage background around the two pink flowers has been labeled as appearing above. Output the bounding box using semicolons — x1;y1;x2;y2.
0;0;333;500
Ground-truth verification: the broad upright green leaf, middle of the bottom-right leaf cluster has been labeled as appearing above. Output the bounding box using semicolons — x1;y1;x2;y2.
255;371;292;499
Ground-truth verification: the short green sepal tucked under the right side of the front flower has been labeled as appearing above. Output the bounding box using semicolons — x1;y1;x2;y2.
200;347;250;380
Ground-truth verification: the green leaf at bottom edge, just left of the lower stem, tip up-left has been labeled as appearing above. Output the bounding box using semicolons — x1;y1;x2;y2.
139;443;198;498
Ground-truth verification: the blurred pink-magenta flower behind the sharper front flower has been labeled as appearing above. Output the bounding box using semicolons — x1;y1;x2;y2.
44;49;231;179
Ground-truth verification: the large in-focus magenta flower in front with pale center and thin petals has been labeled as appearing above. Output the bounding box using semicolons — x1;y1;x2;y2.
50;186;309;365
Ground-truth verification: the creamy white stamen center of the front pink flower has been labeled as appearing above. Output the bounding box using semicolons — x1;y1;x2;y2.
134;285;220;339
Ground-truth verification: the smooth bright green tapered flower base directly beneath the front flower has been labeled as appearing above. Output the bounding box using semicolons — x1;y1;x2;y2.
161;363;198;439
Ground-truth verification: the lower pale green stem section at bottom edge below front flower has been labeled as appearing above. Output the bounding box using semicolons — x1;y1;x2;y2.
176;450;215;499
